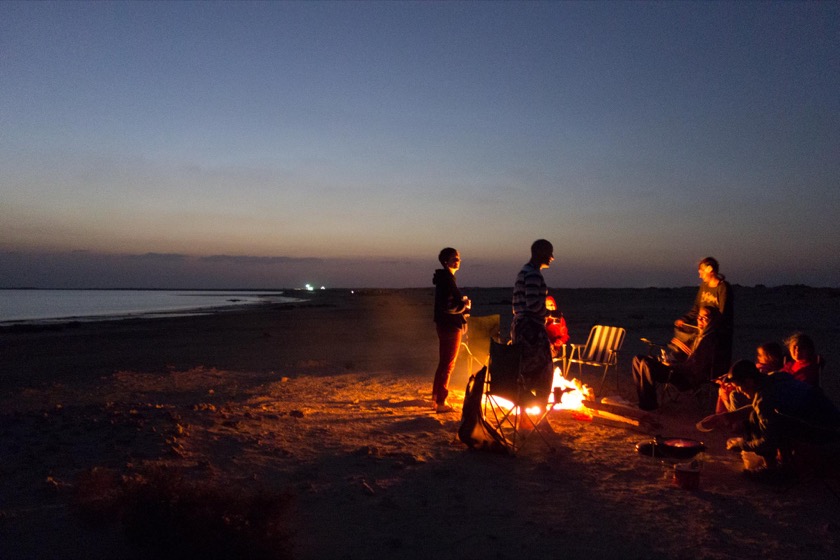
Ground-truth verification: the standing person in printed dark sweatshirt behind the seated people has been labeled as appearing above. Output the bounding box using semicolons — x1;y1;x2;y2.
669;257;735;374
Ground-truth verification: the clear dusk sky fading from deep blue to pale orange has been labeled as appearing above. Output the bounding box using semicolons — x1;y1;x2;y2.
0;1;840;288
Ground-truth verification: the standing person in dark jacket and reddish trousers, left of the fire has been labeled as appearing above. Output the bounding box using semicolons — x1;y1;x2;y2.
432;247;472;412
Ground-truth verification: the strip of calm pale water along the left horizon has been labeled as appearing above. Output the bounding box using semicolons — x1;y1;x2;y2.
0;290;296;323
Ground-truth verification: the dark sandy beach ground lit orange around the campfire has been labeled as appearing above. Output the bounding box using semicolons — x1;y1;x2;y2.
0;286;840;560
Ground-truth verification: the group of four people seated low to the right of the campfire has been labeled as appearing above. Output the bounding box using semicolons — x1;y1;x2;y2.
633;307;840;471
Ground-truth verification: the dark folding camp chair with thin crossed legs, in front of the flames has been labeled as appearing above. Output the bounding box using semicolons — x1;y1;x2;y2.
484;341;553;455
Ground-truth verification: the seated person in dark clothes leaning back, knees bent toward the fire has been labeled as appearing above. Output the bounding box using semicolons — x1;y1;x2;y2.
633;307;720;410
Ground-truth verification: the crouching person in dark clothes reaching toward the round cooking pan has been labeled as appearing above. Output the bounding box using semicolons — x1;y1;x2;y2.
698;360;840;468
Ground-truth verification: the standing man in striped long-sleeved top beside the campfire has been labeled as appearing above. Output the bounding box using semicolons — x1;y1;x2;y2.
510;239;554;404
